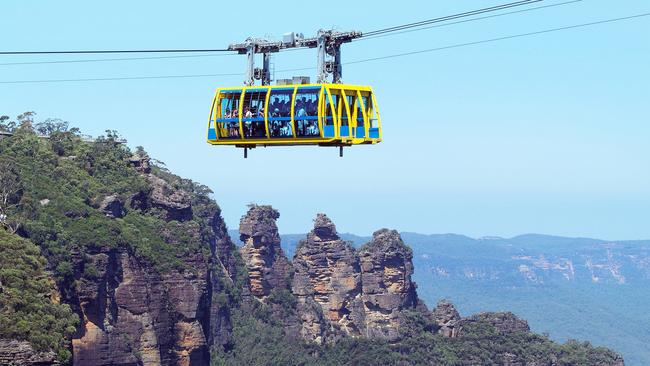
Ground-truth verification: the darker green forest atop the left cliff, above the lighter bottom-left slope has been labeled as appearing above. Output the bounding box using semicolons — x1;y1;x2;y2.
0;115;218;284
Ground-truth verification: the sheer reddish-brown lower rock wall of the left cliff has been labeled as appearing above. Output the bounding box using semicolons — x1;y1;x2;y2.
73;250;210;365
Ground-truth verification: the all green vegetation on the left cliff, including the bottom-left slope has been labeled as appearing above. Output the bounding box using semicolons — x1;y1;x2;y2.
0;112;219;361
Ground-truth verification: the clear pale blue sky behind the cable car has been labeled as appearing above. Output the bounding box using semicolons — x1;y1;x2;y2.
0;0;650;239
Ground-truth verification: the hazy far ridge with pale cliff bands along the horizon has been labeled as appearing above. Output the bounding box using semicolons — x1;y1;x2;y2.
230;230;650;284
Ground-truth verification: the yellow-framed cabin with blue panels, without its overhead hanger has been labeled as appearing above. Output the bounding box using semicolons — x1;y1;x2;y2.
208;84;382;148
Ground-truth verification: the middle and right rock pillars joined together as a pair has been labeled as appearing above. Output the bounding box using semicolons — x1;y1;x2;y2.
292;214;418;342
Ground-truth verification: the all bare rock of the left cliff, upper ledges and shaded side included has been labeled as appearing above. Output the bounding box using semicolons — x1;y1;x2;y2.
70;155;235;365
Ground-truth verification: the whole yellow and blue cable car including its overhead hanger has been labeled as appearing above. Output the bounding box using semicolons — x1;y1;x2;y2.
207;30;382;157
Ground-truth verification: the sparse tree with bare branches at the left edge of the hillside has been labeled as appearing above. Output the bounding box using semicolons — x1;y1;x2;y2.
0;159;22;233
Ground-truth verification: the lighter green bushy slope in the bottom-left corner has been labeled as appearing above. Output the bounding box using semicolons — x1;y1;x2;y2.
0;229;79;362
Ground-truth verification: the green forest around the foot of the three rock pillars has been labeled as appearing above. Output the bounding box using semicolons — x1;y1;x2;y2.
212;298;617;366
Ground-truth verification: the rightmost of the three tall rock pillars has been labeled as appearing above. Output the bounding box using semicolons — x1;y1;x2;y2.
359;229;418;340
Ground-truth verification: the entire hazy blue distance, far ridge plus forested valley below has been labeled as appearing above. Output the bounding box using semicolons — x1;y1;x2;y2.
231;230;650;366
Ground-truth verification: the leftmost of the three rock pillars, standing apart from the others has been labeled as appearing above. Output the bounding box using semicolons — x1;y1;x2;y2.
239;205;291;298
